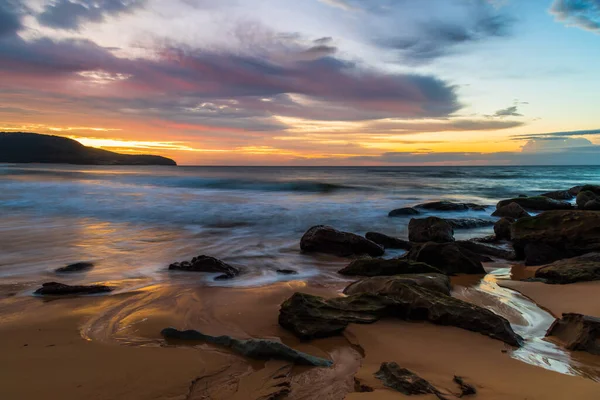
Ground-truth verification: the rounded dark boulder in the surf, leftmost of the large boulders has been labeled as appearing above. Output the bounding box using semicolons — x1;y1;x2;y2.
300;225;384;257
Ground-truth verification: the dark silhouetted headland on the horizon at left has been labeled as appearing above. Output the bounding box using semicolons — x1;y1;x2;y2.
0;132;177;165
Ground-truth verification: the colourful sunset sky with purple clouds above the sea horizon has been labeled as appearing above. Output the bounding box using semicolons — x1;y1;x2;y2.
0;0;600;166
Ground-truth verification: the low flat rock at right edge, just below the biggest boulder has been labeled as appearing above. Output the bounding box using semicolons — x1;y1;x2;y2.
535;253;600;285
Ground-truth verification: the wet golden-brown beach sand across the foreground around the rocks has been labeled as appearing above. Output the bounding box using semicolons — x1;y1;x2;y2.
0;281;600;400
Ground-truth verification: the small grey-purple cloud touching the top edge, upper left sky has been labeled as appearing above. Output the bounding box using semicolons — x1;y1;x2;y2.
37;0;146;30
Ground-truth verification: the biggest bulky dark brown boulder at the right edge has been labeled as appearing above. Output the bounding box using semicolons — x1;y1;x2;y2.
511;210;600;264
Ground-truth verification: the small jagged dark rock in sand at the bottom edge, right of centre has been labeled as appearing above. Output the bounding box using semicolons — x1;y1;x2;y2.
375;362;444;399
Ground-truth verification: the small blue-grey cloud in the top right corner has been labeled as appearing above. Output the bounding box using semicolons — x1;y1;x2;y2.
550;0;600;34
